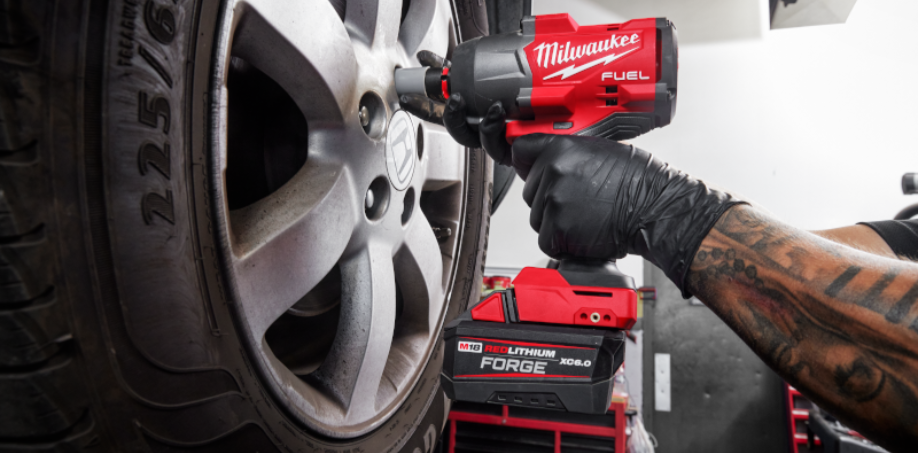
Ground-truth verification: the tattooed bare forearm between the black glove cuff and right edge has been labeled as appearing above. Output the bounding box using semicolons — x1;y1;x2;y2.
687;205;918;452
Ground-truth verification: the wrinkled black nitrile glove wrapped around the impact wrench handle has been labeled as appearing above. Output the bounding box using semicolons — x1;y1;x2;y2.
512;134;743;298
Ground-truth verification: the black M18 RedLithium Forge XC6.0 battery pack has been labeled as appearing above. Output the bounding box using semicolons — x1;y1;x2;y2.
440;319;625;414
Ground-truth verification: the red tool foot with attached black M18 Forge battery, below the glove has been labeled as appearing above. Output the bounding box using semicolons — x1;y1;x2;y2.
440;261;637;414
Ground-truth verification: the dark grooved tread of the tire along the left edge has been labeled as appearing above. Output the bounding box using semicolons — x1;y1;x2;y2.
0;0;95;446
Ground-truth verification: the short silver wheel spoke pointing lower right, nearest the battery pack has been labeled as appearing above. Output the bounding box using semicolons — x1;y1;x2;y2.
395;210;444;332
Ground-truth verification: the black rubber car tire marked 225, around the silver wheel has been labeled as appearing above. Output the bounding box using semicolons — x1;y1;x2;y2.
0;0;492;453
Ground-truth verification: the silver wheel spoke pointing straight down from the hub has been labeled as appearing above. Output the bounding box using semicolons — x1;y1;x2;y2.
311;242;395;422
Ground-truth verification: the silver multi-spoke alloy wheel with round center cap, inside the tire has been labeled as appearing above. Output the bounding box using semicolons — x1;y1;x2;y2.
210;0;466;438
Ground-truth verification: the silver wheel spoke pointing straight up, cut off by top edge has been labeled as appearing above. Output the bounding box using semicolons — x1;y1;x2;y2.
344;0;402;48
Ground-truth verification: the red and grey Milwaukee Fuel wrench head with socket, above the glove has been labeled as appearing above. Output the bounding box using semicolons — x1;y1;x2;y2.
395;14;678;143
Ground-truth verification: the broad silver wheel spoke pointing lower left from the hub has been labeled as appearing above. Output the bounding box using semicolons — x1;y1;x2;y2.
230;163;359;341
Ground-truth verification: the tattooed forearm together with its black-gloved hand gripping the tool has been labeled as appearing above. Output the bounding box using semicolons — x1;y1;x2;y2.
512;134;918;452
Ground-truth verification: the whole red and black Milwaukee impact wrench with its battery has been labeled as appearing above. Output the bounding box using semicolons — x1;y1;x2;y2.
395;14;678;414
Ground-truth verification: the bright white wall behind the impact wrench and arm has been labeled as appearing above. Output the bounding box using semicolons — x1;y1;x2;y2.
487;0;918;284
